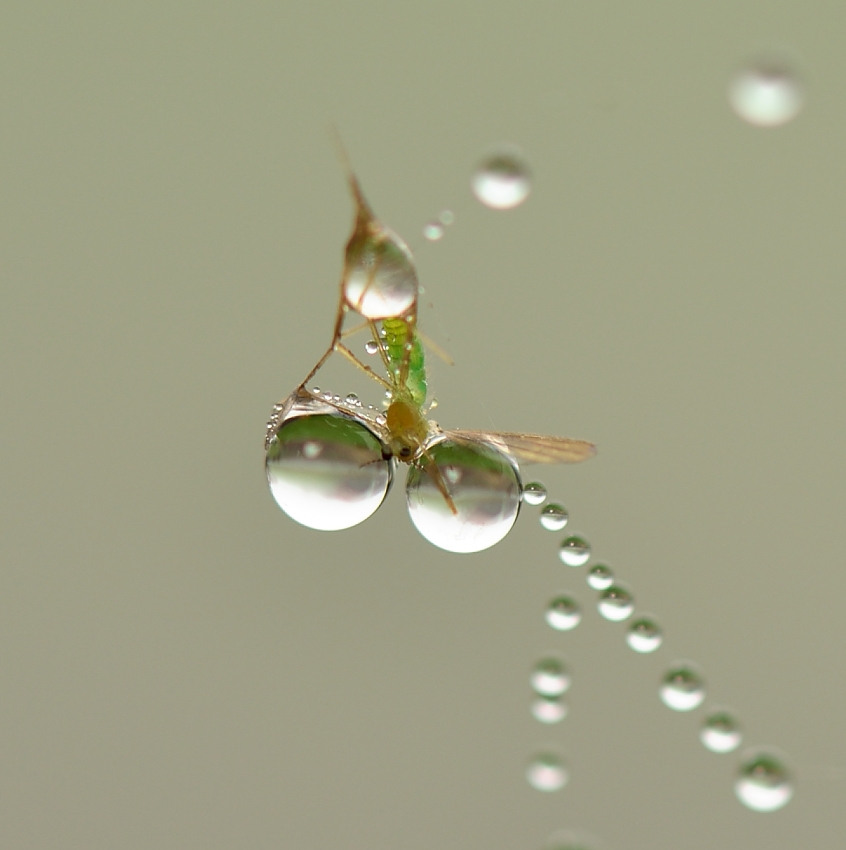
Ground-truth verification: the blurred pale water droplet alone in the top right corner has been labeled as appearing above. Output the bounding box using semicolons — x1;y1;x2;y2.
729;59;805;127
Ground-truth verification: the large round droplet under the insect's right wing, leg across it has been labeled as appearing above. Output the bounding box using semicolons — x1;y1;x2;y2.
406;437;522;552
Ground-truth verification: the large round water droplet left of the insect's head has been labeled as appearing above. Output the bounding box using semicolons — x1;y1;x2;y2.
265;402;391;531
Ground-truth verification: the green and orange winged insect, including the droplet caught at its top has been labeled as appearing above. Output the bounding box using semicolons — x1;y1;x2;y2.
276;142;596;516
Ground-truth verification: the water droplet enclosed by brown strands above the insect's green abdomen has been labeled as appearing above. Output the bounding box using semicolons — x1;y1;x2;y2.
344;227;418;320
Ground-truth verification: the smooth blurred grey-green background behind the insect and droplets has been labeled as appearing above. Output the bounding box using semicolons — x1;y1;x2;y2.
0;0;846;850
